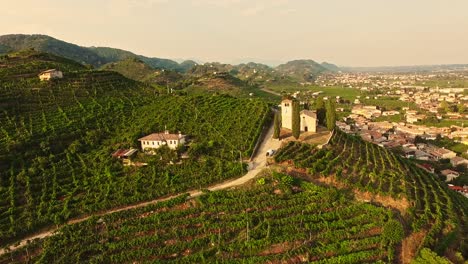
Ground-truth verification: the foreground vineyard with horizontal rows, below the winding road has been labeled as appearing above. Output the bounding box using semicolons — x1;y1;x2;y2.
0;173;402;263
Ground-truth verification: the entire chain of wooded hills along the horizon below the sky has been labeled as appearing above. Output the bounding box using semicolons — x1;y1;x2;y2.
0;34;339;83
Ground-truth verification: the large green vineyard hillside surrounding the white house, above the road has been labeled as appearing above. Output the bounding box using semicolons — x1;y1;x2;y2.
0;54;269;246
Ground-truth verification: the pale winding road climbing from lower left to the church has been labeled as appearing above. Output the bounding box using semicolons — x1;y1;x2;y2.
0;120;281;255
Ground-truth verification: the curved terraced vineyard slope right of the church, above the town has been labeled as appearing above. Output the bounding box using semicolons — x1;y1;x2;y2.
275;131;468;257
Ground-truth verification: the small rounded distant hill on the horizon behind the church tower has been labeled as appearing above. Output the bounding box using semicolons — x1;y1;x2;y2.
275;60;330;82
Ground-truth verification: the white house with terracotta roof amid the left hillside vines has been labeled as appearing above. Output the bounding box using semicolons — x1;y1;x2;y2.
138;130;185;151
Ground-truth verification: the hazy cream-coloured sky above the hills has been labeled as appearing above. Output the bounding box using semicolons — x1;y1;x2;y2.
0;0;468;66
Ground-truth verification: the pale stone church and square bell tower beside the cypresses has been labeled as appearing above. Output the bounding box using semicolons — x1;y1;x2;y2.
281;99;318;133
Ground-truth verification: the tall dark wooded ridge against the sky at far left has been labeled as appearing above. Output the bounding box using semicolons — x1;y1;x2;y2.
0;34;187;71
